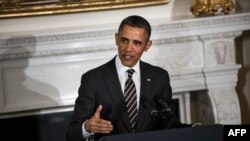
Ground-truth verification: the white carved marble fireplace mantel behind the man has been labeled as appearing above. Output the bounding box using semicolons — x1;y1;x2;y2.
0;13;250;124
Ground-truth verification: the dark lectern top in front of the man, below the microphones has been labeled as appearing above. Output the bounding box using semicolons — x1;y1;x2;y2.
99;125;223;141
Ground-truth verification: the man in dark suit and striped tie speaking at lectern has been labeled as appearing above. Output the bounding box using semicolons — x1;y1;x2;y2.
67;16;179;141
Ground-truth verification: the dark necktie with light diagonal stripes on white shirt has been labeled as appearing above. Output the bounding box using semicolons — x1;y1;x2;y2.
124;69;137;132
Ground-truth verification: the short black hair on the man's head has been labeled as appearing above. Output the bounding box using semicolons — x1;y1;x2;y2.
118;15;151;40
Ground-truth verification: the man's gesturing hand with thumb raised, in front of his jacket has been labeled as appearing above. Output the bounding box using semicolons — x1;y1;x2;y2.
85;105;113;134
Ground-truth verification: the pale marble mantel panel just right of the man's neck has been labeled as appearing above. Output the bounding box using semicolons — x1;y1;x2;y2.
146;41;203;71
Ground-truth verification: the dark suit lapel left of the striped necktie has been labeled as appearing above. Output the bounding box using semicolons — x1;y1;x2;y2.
104;59;131;131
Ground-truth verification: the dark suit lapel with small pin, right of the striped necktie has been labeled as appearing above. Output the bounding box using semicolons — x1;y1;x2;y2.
136;61;152;131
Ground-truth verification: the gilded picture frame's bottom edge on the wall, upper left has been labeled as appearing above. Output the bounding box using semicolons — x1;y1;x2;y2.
0;0;169;18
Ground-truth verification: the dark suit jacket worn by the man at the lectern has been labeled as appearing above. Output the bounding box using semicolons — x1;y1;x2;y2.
67;56;172;141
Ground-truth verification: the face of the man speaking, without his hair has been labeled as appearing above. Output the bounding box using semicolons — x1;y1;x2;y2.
115;25;152;68
